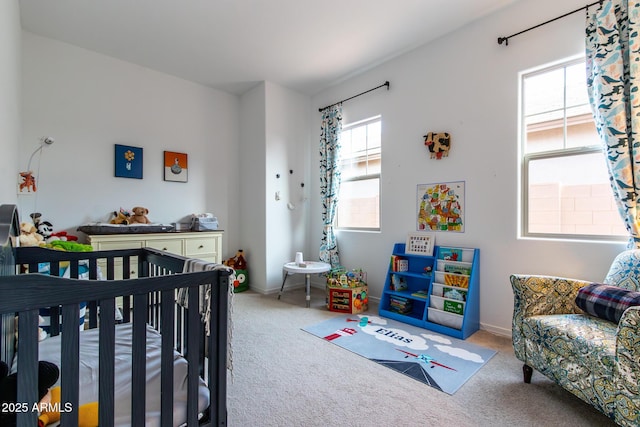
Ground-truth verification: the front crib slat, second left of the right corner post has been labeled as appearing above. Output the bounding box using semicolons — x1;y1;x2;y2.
160;290;175;427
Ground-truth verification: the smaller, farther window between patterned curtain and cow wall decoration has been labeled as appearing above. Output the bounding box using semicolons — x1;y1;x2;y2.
337;116;382;230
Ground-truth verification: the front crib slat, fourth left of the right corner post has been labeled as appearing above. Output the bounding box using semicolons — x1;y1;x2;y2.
98;298;116;427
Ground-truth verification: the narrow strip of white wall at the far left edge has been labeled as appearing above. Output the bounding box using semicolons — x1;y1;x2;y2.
0;0;21;204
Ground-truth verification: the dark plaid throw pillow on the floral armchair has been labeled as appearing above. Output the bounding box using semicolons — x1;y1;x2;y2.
576;283;640;323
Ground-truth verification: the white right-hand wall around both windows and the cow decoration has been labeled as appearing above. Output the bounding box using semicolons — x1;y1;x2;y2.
311;0;624;335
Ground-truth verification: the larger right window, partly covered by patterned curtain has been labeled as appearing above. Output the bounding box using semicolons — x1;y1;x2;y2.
520;59;627;239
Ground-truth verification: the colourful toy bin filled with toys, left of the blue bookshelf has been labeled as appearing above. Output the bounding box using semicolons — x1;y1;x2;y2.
327;268;369;314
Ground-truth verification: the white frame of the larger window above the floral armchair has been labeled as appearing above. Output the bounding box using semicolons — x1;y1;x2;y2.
518;56;628;242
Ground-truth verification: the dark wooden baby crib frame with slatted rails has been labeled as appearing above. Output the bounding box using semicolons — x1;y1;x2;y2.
0;246;228;426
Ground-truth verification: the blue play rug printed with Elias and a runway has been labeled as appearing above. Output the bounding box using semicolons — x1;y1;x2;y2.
302;313;496;394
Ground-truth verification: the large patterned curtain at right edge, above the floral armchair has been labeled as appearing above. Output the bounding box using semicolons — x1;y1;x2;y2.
586;0;640;248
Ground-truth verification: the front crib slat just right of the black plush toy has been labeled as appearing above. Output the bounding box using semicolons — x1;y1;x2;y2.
60;304;80;427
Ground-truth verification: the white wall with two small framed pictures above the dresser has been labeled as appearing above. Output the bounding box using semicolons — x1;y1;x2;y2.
19;32;239;256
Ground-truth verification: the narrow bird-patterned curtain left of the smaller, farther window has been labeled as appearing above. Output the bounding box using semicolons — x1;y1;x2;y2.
320;104;342;267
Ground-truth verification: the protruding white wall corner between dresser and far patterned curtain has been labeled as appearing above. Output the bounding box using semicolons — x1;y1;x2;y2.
240;82;310;293
